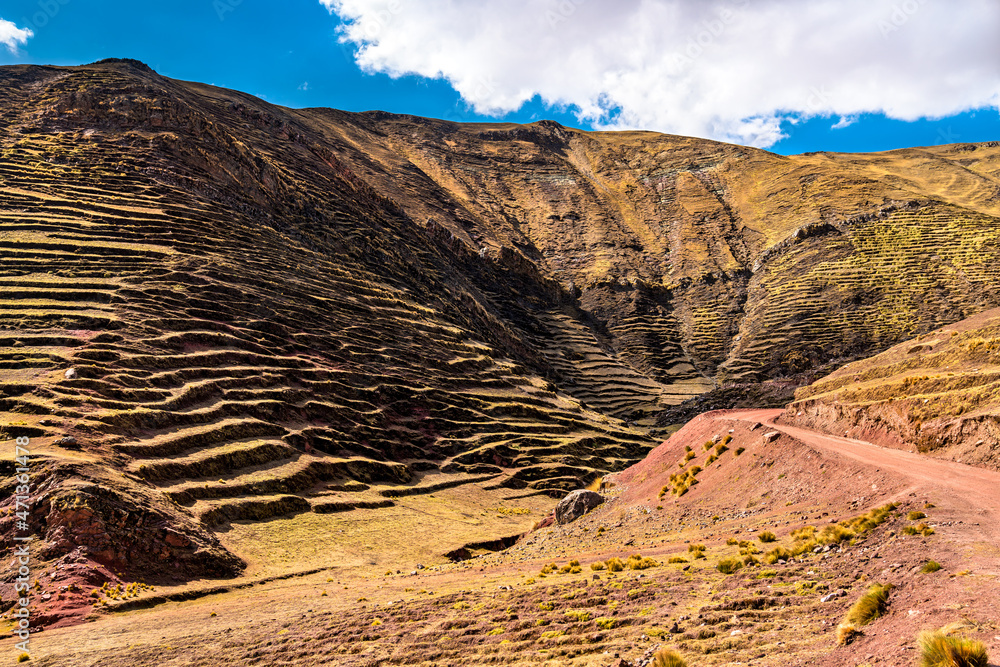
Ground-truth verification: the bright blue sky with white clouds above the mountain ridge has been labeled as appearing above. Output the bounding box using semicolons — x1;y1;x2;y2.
0;0;1000;154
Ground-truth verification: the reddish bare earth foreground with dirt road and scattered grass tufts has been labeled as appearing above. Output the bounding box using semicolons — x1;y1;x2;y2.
17;410;1000;667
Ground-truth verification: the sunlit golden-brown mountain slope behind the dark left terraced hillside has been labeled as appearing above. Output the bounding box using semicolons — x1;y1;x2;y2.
309;116;1000;386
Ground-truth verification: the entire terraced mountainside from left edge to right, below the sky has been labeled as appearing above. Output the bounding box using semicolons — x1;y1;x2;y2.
0;61;1000;592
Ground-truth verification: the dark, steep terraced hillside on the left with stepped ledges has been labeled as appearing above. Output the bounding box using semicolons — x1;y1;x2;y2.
0;63;652;576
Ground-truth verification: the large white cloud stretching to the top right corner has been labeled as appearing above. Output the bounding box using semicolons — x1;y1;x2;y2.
320;0;1000;146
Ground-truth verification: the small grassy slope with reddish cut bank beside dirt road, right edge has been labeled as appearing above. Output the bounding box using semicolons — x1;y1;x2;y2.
786;309;1000;470
